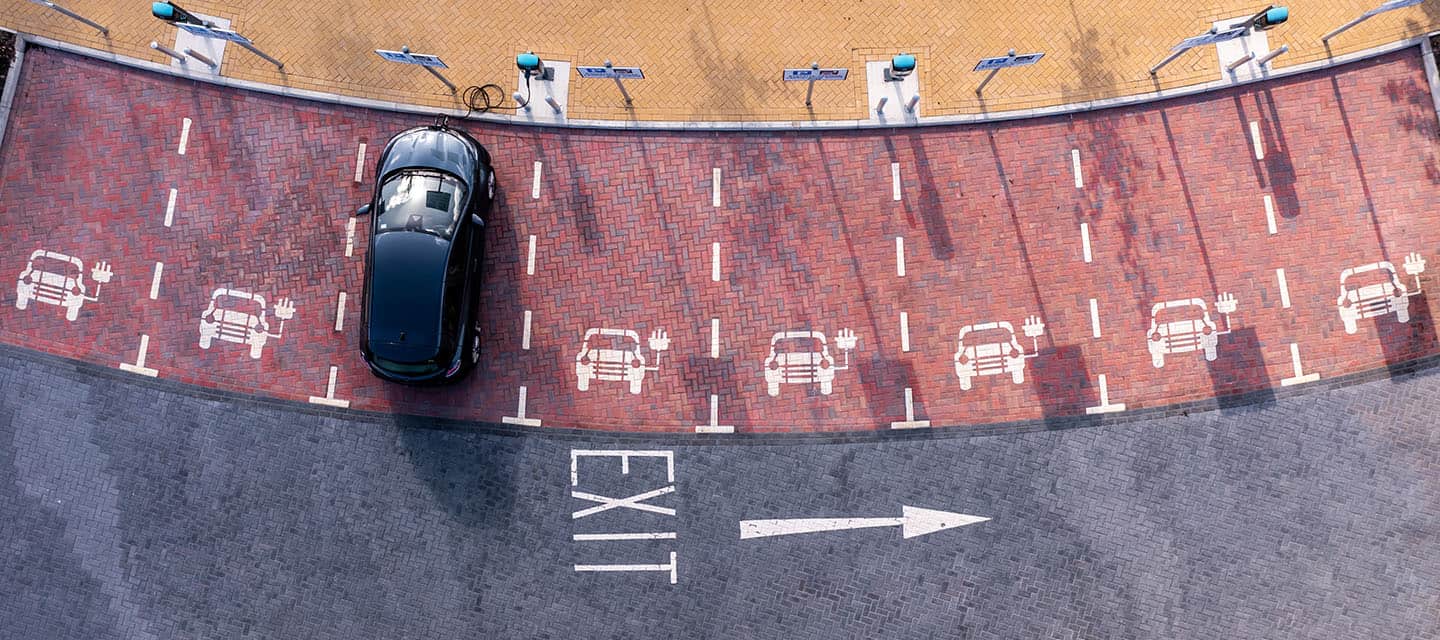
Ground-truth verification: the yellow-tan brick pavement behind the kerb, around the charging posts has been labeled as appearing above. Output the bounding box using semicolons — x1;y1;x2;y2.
0;0;1440;121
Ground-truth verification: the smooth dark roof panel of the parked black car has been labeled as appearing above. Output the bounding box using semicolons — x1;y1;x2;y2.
366;231;451;362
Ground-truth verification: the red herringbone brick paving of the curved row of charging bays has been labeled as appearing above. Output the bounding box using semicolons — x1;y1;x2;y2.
0;49;1440;431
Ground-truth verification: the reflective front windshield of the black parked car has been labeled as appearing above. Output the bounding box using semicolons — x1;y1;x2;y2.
377;172;465;239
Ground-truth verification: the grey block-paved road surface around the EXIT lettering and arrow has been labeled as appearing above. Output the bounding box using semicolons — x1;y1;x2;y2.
0;349;1440;640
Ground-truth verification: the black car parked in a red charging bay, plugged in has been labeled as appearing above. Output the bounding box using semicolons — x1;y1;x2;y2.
357;124;495;383
